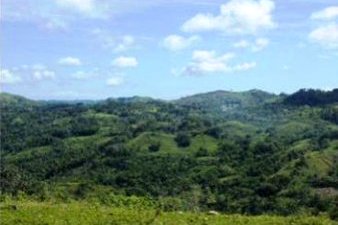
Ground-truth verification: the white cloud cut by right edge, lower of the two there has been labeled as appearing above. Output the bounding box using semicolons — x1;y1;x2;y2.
309;23;338;49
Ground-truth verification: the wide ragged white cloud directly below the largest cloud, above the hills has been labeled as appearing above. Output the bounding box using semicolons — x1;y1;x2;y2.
175;51;256;75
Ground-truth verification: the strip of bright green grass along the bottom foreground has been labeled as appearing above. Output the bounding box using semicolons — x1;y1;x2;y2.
0;201;335;225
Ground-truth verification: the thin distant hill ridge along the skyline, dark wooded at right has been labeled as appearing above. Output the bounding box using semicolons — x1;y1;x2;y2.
0;89;338;111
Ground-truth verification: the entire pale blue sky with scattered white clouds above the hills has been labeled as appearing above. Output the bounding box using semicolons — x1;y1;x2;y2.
0;0;338;100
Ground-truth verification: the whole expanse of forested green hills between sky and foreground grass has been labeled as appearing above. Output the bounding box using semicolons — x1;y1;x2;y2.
0;89;338;217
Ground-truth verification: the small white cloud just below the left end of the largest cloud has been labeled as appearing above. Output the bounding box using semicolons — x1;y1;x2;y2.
163;34;200;51
